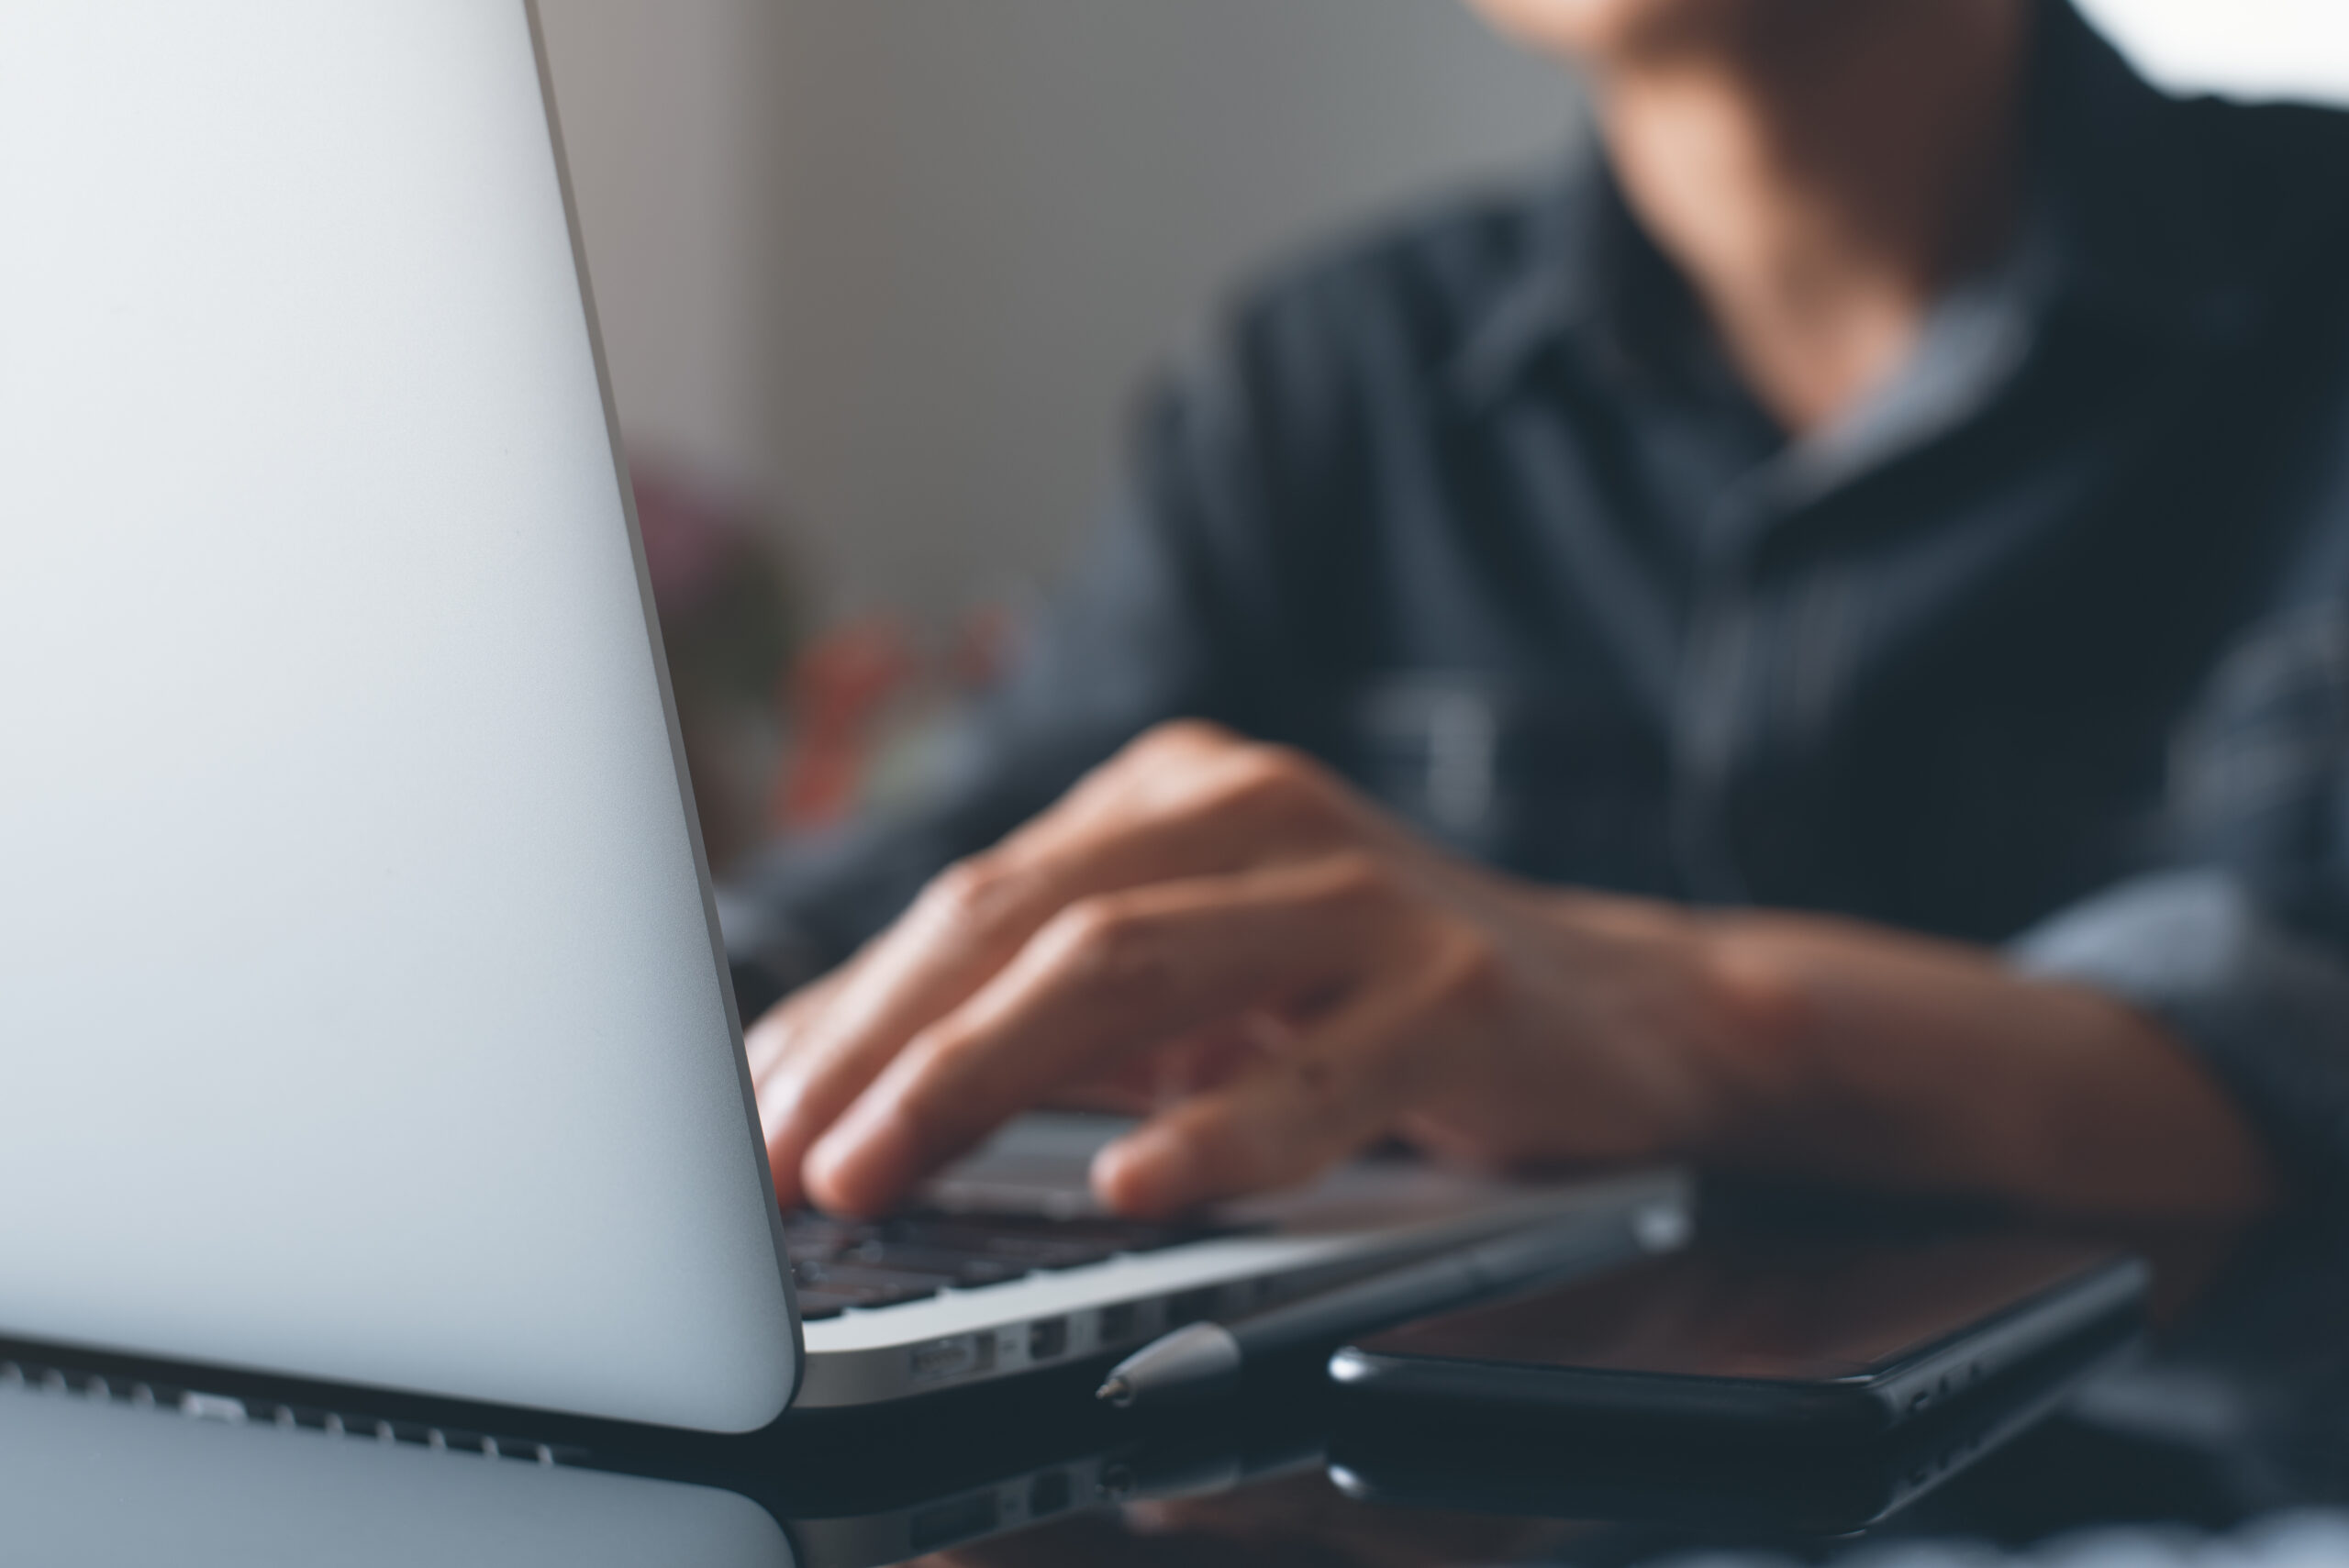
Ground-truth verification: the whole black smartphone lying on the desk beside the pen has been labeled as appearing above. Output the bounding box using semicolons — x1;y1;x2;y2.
1330;1235;2149;1441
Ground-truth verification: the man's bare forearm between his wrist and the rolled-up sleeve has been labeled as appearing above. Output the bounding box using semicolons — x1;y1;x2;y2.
1698;916;2278;1216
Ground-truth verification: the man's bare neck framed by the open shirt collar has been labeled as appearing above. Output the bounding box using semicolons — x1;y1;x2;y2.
1595;0;2030;434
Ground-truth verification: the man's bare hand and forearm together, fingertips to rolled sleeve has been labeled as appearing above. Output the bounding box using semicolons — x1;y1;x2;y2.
750;723;2269;1214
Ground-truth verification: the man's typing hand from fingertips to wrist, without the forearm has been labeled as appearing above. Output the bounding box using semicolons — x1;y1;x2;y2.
751;723;1766;1214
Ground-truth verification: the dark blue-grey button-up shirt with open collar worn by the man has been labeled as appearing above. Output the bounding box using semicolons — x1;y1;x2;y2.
726;3;2349;1193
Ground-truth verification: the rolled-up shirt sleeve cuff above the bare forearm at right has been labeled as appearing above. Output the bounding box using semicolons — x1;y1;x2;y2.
2009;869;2349;1202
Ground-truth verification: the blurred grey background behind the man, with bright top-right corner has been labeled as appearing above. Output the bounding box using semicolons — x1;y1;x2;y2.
540;0;2349;859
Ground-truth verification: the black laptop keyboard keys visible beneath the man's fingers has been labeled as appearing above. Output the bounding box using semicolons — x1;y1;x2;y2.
782;1211;1230;1319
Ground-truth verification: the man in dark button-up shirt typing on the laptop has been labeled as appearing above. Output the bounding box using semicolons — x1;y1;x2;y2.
729;0;2349;1214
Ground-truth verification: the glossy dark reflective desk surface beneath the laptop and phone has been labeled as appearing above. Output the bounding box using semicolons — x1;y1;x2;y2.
0;1187;2349;1568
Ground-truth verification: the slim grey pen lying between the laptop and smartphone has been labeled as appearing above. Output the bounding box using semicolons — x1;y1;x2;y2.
1097;1204;1689;1408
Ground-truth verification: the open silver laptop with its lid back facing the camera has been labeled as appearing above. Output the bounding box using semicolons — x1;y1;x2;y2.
0;0;1685;1432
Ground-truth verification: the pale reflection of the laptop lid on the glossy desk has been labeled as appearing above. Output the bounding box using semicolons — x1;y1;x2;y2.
0;1363;794;1568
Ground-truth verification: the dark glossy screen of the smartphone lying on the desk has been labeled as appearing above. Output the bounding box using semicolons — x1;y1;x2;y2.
1363;1237;2119;1383
